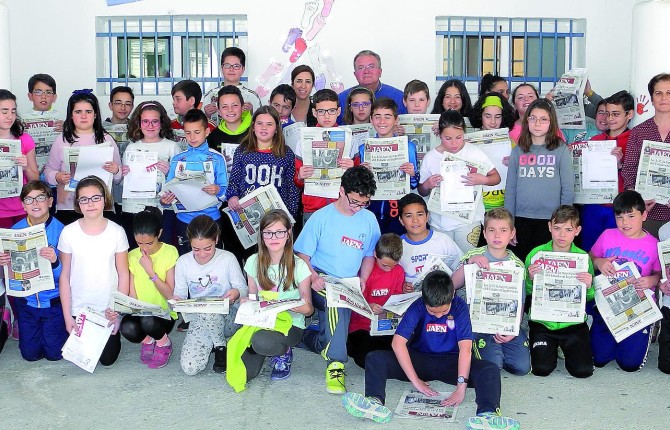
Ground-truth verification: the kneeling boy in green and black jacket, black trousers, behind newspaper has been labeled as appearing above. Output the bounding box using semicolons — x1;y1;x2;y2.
526;205;594;378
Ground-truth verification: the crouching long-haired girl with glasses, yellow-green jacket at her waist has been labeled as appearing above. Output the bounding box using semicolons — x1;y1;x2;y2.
242;209;314;381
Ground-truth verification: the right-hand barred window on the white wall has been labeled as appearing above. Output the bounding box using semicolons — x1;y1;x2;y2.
436;17;586;94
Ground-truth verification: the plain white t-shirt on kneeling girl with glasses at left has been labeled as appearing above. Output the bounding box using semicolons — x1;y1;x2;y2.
58;220;128;315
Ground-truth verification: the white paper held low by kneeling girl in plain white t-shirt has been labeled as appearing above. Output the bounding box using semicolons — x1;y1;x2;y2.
62;308;114;373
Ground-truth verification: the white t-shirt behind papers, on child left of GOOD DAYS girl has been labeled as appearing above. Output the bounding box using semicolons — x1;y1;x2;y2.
420;143;495;231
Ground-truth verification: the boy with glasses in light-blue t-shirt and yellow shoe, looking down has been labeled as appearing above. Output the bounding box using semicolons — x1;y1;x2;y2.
294;166;381;394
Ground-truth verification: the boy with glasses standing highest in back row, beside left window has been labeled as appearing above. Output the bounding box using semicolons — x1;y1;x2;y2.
201;46;262;124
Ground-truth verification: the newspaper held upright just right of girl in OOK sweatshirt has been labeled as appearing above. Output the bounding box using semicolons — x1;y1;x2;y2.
300;127;351;199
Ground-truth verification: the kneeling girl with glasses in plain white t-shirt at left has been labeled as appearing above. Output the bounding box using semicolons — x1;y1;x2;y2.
58;176;130;366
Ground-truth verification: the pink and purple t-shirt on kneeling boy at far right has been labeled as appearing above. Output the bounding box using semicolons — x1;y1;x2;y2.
591;228;661;276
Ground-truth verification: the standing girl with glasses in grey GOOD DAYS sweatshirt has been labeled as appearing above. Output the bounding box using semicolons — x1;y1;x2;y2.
505;99;575;261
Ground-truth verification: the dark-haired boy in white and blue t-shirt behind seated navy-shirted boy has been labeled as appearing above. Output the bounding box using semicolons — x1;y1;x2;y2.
398;193;463;293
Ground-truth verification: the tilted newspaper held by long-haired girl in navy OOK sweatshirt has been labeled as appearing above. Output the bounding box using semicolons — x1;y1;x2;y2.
223;184;295;249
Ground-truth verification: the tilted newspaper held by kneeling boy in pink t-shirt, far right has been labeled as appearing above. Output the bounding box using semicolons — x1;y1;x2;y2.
595;261;663;342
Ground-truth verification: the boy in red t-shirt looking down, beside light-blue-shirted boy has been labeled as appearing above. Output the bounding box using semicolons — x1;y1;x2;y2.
347;233;405;369
